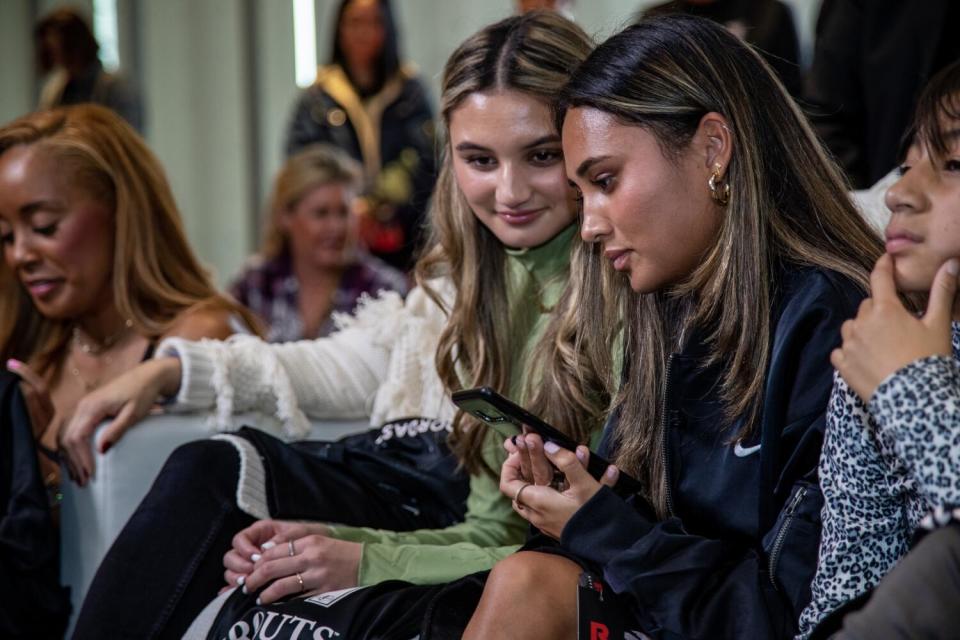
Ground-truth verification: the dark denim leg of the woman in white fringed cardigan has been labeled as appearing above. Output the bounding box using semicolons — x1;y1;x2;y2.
73;440;254;640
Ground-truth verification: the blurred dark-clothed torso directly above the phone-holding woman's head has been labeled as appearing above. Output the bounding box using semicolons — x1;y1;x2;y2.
642;0;802;97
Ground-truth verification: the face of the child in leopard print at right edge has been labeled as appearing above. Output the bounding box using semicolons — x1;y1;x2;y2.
886;122;960;292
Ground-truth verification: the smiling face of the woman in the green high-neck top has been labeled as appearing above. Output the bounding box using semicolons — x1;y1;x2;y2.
450;90;576;248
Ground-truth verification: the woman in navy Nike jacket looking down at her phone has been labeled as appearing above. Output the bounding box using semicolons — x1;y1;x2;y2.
464;16;882;639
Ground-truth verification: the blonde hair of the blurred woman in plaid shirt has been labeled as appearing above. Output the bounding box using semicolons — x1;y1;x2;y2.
260;144;363;260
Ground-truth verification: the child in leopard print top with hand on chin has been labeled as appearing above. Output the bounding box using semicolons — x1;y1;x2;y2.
800;63;960;638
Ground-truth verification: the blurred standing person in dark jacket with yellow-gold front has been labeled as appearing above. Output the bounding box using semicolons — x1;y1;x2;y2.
287;0;435;271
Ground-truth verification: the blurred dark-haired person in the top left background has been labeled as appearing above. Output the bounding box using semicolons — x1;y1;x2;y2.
33;7;143;132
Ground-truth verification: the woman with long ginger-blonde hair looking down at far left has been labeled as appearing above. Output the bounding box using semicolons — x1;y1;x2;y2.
0;105;253;637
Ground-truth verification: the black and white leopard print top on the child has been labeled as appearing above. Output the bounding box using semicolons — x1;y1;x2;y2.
798;322;960;638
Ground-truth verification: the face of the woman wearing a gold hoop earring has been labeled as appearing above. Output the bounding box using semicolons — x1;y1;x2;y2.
563;107;724;293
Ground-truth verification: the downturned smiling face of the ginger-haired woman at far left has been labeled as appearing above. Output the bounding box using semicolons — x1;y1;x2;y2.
0;145;114;319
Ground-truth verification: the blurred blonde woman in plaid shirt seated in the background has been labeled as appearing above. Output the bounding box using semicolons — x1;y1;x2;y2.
230;145;407;342
